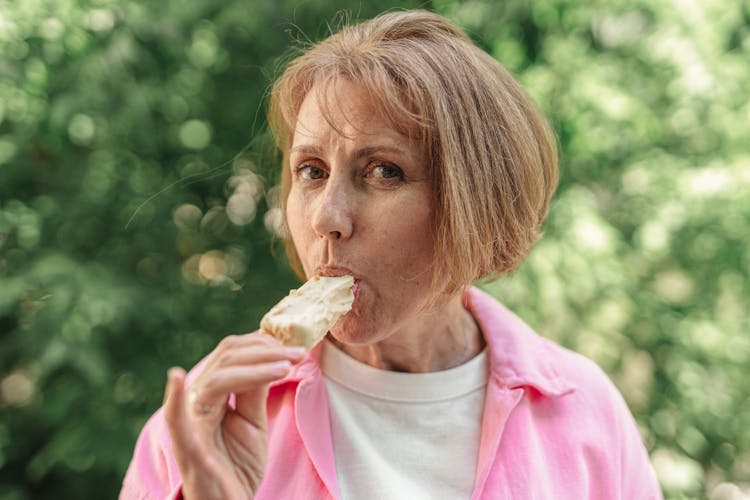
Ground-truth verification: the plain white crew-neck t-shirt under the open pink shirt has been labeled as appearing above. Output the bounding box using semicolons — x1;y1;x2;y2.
321;340;489;500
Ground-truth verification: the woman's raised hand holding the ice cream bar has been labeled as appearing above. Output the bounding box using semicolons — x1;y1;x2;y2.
164;333;305;500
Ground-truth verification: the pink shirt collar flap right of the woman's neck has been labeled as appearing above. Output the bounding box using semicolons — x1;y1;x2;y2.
464;287;576;396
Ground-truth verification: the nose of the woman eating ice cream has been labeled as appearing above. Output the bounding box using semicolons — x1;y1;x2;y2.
313;175;354;240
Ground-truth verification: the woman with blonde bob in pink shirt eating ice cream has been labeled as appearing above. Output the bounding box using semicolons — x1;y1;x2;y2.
121;11;661;499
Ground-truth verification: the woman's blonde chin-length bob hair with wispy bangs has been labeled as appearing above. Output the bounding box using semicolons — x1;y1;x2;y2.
268;10;558;292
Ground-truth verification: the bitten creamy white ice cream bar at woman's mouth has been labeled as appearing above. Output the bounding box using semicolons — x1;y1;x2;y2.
260;276;354;349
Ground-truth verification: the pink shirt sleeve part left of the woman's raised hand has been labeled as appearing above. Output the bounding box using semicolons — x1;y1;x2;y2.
120;409;182;500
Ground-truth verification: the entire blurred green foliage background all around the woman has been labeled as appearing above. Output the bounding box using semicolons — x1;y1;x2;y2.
0;0;750;500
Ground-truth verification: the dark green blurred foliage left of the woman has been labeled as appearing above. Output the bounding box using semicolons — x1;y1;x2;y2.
0;0;426;499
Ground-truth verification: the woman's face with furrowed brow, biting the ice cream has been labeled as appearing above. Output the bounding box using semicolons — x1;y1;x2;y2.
286;82;434;344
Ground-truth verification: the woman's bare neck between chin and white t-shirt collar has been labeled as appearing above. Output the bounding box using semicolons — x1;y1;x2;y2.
331;294;485;373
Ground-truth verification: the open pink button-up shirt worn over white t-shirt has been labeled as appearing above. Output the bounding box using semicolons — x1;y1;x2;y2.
120;289;662;500
